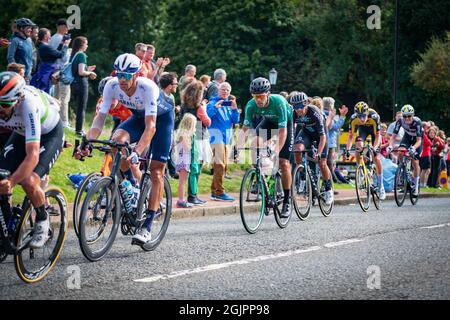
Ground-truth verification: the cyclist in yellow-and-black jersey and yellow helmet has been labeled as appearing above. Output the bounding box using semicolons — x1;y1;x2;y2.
344;101;386;200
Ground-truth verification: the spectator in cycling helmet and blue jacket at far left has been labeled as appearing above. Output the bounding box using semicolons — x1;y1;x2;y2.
7;18;35;83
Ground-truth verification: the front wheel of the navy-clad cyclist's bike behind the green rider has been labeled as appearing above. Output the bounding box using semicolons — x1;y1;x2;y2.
292;165;312;221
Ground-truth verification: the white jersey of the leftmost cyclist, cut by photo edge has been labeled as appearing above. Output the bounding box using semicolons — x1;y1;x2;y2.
0;86;60;143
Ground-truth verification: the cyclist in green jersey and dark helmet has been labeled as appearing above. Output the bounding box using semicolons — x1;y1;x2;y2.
238;78;294;218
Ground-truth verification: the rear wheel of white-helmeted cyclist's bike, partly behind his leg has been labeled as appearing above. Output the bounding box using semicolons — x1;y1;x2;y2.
137;175;172;251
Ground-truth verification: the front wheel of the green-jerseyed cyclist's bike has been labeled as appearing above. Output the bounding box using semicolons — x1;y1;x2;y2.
239;168;265;234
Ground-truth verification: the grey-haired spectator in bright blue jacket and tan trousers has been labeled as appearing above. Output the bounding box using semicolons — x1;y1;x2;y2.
207;82;239;201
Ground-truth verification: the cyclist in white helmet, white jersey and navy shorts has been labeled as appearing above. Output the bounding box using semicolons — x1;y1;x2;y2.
79;53;161;243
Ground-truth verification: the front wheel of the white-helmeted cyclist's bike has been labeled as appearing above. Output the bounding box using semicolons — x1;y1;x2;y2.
78;177;121;262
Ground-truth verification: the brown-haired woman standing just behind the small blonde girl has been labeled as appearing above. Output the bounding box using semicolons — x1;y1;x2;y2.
181;80;211;205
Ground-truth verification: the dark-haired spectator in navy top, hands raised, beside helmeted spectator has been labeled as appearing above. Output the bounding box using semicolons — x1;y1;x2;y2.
30;28;70;93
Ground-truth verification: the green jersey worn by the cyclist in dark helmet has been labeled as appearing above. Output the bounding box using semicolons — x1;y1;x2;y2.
244;94;292;128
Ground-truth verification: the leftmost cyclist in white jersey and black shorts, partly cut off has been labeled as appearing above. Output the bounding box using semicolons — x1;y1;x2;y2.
0;72;64;249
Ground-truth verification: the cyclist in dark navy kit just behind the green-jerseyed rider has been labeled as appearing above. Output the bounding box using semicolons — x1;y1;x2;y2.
290;92;334;206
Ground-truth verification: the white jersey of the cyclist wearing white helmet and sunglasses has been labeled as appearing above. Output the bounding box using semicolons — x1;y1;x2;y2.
99;77;159;116
